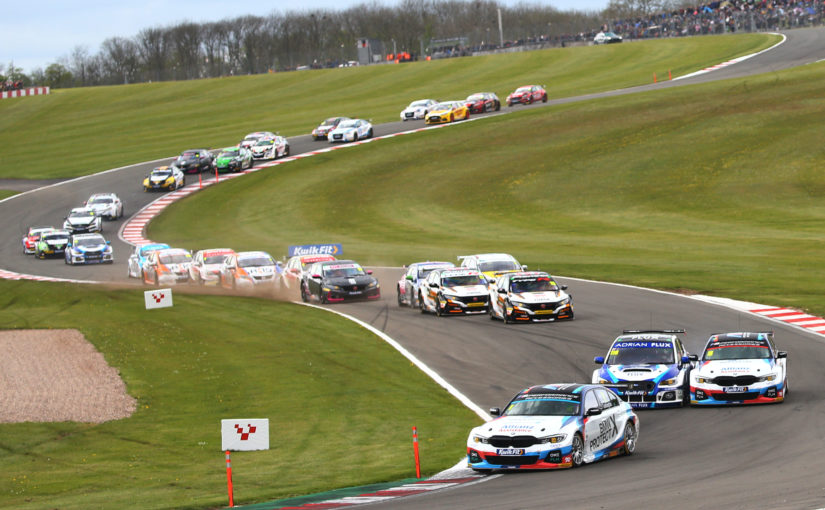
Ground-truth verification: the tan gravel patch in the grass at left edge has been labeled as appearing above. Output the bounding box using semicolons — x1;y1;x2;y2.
0;329;136;423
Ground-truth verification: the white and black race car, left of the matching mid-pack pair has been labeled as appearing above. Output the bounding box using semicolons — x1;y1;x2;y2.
418;268;490;317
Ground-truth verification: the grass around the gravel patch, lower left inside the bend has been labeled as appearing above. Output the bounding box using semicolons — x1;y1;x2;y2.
0;280;479;509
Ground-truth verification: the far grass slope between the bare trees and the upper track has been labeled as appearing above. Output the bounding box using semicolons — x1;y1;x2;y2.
0;34;778;179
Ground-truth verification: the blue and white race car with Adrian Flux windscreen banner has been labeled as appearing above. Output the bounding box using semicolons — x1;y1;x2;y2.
593;329;698;408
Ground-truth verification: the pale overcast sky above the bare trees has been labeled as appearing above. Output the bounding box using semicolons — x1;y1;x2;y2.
0;0;608;73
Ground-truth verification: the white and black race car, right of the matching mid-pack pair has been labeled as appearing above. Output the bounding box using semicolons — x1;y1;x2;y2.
490;271;573;324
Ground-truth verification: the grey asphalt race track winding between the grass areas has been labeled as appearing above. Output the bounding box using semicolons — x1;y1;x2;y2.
0;29;825;510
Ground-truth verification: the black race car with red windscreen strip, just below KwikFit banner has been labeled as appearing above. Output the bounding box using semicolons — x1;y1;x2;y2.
301;260;381;303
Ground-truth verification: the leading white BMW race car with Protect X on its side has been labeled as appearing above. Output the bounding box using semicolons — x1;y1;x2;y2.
467;384;639;472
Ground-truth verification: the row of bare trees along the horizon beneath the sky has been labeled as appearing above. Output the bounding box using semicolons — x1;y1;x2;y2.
0;0;716;88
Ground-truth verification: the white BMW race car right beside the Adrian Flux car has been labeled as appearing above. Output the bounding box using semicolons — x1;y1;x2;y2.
690;331;788;405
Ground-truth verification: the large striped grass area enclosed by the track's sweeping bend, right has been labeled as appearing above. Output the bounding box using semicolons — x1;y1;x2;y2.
149;58;825;314
